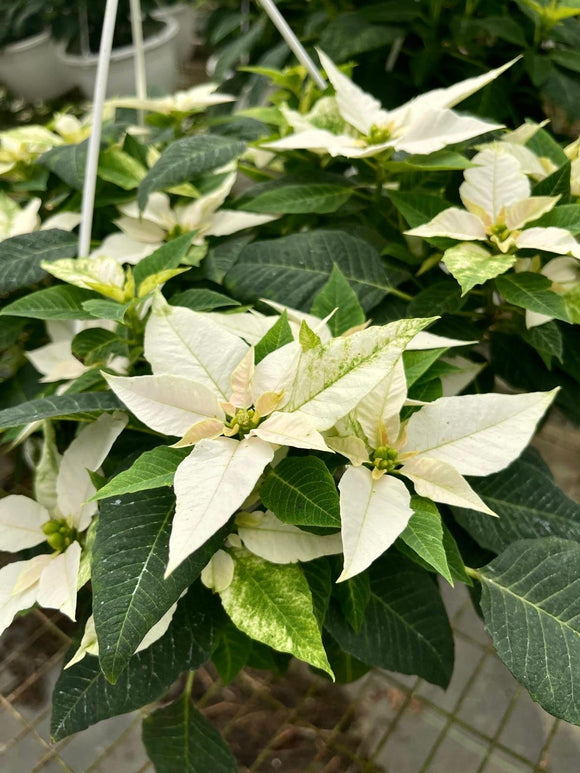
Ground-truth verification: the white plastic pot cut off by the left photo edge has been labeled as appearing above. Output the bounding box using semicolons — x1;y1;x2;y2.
0;32;71;102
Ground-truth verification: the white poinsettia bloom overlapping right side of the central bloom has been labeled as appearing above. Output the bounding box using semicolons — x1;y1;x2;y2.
326;361;557;580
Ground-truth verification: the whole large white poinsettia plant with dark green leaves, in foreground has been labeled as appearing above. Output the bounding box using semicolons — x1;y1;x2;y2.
0;37;580;771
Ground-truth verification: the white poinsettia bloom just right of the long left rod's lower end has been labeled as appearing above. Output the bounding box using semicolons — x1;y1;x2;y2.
92;165;275;264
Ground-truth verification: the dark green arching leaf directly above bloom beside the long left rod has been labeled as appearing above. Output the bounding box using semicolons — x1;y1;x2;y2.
137;134;246;209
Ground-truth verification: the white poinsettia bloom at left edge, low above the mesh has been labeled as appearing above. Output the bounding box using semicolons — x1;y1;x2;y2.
0;413;127;633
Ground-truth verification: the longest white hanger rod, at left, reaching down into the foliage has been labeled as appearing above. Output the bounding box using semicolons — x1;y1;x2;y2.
79;0;118;258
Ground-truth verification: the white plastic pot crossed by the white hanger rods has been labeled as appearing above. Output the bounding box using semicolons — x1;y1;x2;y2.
57;19;179;99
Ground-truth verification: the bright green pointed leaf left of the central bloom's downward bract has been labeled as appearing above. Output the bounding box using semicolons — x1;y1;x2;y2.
91;446;191;501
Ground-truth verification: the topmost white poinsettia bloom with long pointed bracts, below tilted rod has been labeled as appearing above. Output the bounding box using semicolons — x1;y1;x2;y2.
263;51;513;158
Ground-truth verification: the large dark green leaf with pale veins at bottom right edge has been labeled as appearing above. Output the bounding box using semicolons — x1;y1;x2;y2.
480;537;580;724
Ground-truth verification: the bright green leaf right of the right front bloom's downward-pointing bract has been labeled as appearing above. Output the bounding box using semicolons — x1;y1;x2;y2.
400;496;453;585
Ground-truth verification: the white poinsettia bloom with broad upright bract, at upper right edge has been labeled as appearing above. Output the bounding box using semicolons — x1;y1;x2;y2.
405;147;580;258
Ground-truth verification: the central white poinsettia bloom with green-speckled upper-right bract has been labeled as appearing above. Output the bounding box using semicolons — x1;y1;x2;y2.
104;299;431;574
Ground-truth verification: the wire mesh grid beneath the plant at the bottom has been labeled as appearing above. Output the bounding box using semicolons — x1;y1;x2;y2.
0;589;580;773
